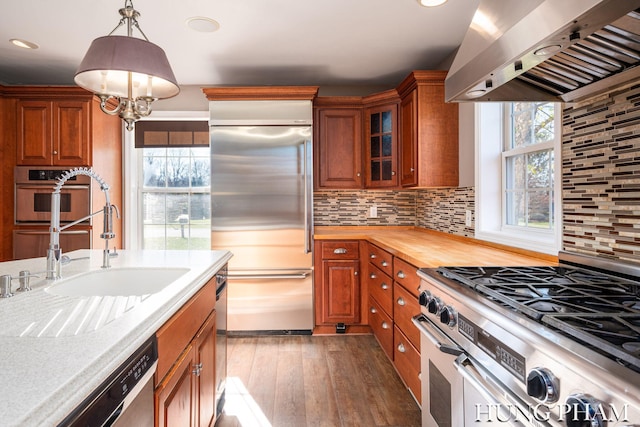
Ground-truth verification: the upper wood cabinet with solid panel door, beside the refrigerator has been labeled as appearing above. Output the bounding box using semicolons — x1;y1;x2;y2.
313;97;364;189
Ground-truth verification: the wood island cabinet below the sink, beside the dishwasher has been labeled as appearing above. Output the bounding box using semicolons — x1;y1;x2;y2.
154;278;216;427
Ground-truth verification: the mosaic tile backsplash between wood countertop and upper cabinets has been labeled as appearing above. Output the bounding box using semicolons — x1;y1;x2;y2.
313;187;474;236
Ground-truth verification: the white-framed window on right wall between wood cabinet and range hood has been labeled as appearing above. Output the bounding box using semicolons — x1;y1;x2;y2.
476;102;561;254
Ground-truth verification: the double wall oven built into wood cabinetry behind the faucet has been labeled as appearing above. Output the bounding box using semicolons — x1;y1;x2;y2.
13;166;91;259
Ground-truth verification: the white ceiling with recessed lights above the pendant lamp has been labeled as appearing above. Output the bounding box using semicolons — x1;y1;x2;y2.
0;0;479;106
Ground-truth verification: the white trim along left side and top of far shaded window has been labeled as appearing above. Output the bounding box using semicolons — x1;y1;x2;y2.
123;111;209;250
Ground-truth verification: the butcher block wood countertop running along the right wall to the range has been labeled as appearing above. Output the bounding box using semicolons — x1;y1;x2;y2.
314;226;558;268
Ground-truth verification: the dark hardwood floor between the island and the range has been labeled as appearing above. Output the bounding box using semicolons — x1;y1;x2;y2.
216;335;421;427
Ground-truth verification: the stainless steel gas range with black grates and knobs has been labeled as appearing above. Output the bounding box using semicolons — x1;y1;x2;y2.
414;253;640;427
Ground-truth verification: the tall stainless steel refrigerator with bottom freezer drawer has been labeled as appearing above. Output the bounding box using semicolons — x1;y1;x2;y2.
209;101;313;334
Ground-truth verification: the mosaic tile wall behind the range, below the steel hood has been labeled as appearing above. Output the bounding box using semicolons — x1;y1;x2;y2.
562;85;640;263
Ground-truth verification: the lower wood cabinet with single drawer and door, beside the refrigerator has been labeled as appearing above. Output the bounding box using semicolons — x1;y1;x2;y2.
315;240;361;332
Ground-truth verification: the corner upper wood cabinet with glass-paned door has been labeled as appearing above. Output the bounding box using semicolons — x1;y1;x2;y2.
363;90;400;188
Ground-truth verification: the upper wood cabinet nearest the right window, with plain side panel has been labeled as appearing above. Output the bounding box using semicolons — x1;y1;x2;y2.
397;71;458;187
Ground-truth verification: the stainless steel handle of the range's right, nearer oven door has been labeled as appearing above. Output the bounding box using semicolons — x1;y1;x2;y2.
453;354;547;427
